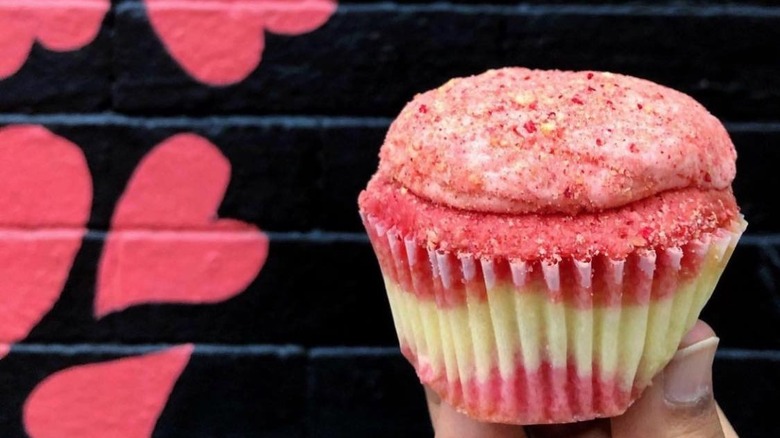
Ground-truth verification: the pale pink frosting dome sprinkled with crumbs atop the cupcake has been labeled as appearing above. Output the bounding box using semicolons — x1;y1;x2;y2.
379;68;736;213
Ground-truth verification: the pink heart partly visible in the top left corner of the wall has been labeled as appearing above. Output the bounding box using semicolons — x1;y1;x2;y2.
0;0;111;79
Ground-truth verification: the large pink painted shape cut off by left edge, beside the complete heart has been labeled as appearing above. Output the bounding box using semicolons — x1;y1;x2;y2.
0;125;92;353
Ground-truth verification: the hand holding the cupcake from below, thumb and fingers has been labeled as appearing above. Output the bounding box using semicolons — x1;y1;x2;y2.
425;321;737;438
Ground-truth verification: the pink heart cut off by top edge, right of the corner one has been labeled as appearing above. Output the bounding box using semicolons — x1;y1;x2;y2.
144;0;336;85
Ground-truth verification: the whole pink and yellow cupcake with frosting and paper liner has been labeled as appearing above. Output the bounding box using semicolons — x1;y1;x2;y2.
359;68;745;424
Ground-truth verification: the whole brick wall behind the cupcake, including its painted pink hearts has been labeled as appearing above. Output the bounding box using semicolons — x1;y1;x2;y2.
0;0;780;438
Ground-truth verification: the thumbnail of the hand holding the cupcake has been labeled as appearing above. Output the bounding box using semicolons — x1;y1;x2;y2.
663;337;719;405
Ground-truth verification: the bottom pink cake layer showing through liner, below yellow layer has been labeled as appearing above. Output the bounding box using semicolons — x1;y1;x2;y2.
401;346;642;424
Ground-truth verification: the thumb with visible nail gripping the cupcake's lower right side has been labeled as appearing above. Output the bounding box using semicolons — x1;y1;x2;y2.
612;322;724;438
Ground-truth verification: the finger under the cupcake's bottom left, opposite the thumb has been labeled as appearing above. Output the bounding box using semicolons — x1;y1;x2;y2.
425;387;527;438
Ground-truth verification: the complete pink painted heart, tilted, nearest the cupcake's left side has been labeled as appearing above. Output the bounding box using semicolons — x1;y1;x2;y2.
95;134;268;318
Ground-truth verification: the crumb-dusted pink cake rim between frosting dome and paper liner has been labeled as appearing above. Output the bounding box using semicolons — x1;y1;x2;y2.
359;175;739;261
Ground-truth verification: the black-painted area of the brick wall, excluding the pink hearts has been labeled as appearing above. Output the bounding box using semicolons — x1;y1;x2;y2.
0;0;780;437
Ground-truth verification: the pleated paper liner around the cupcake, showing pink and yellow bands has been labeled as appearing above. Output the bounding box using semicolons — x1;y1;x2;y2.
364;217;745;424
